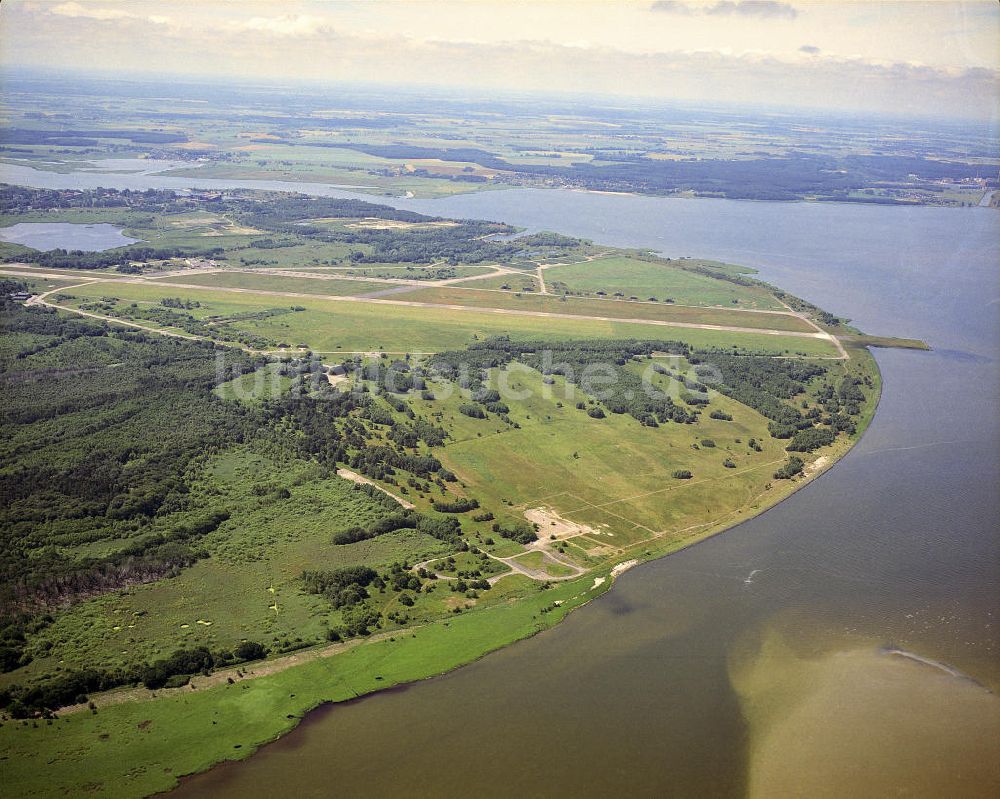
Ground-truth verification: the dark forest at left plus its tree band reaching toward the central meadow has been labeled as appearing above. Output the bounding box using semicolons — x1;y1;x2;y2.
0;300;460;670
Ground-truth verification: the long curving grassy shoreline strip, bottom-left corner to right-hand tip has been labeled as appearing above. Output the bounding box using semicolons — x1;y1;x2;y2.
0;351;882;797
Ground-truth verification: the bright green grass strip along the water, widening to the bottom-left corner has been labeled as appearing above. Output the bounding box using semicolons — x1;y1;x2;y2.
0;575;608;797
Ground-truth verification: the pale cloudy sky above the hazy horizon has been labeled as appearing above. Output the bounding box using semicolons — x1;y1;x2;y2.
0;0;1000;119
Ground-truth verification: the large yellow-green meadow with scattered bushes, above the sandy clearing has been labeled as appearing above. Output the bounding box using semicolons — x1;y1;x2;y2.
426;369;785;548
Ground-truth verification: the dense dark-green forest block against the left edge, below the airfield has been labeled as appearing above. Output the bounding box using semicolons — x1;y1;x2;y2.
0;301;256;621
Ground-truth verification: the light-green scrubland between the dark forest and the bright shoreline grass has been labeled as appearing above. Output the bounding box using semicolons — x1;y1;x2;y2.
0;449;458;684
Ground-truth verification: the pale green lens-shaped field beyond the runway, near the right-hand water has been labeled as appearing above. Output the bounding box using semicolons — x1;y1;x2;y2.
545;257;783;311
